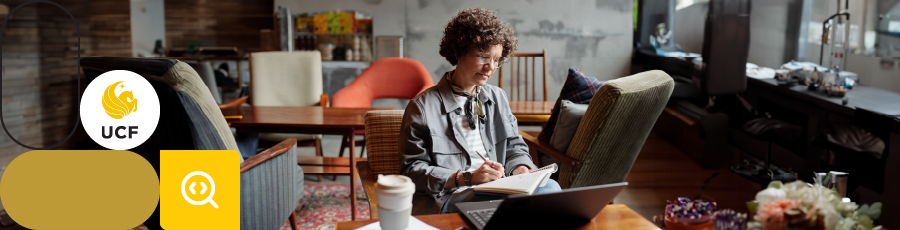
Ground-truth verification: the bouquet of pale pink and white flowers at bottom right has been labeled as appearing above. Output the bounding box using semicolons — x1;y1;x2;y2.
747;179;881;230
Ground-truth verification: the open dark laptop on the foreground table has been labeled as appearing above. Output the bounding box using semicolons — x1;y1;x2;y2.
456;182;628;230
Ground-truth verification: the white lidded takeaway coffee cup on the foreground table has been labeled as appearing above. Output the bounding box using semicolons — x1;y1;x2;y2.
375;175;416;230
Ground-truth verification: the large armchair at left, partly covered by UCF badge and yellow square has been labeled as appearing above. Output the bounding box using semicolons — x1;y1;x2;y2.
81;57;303;229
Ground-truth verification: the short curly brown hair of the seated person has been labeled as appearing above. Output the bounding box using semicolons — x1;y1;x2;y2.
440;7;519;66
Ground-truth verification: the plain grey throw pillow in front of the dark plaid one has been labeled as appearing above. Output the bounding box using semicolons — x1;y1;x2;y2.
550;100;588;153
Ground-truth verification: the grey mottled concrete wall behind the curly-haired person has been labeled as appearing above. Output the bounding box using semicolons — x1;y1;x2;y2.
275;0;633;100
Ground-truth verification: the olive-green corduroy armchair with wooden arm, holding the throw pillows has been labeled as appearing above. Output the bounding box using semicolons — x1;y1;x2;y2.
519;70;675;189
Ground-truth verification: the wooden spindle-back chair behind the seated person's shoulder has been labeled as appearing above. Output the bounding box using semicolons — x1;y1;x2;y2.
497;49;547;102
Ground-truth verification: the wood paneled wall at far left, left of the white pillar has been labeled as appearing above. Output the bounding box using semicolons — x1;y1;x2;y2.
0;0;131;169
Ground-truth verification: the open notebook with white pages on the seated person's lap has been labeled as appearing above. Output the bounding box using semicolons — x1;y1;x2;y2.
474;164;559;195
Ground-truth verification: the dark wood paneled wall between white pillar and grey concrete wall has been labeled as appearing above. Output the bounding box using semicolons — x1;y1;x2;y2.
165;0;277;51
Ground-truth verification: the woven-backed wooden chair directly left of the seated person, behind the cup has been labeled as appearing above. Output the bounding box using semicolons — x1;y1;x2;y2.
356;110;403;219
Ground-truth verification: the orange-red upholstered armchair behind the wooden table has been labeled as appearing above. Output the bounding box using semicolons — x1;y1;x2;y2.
331;57;434;157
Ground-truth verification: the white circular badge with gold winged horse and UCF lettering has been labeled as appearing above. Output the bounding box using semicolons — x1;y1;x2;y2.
81;70;159;150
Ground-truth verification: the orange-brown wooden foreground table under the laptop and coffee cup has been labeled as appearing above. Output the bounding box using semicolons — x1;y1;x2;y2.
335;204;659;230
